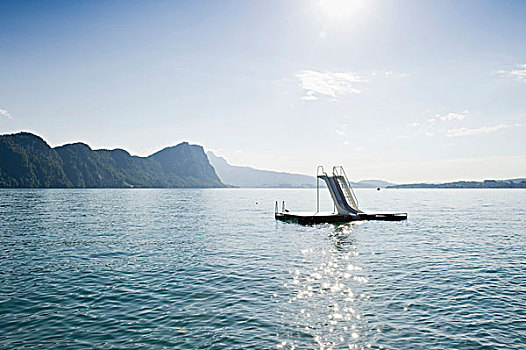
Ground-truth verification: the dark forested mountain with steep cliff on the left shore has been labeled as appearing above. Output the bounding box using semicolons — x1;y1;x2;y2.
0;132;225;188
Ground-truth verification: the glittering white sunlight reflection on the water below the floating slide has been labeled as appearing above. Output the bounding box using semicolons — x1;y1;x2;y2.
277;225;376;349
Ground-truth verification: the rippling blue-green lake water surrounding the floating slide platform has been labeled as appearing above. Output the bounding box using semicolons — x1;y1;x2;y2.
0;189;526;349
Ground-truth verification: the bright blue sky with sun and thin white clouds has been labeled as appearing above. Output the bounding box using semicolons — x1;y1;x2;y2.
0;0;526;183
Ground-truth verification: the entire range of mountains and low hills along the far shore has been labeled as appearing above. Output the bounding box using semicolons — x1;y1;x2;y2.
5;132;526;188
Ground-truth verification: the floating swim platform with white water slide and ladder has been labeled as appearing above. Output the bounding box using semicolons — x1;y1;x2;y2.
274;165;407;225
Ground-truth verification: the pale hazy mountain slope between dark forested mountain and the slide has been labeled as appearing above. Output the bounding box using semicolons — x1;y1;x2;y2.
207;151;316;188
